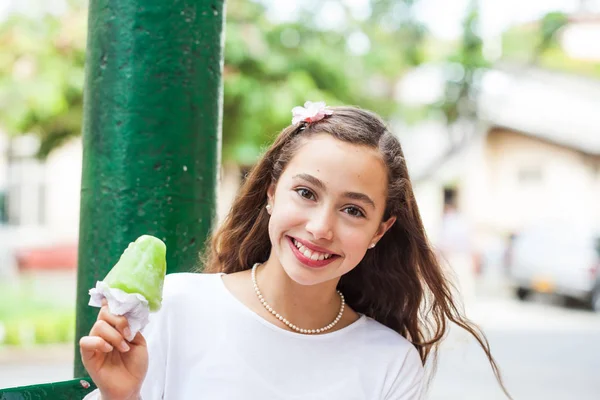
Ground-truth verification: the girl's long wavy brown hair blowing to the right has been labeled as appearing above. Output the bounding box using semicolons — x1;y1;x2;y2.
202;107;510;398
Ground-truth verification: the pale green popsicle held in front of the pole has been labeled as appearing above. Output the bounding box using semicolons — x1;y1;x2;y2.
104;235;167;311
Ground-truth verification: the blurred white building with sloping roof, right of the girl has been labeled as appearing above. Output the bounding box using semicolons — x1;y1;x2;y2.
401;68;600;286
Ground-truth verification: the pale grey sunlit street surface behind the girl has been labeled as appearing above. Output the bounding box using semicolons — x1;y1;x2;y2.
0;292;600;400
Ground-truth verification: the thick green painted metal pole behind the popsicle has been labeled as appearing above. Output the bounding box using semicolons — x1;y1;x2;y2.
74;0;224;377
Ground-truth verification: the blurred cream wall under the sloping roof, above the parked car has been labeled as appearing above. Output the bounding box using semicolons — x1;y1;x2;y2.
482;130;600;231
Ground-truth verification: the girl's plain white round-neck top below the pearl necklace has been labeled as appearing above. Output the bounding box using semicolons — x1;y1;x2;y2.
86;273;423;400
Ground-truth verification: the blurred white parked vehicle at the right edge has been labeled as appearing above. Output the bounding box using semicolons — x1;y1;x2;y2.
507;224;600;312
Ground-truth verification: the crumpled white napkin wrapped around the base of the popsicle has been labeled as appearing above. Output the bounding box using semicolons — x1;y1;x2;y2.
88;281;150;342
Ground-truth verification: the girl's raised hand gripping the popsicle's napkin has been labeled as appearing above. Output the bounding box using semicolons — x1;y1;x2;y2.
79;300;148;400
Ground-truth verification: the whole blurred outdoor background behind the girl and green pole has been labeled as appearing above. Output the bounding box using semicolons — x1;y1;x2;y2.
0;0;600;400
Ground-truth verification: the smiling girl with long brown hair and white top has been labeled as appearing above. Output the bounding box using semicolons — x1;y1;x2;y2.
80;102;506;400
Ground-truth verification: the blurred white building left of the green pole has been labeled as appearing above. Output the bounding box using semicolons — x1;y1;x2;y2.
0;135;82;275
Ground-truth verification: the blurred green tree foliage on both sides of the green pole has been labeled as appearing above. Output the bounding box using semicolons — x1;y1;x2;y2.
0;0;432;164
